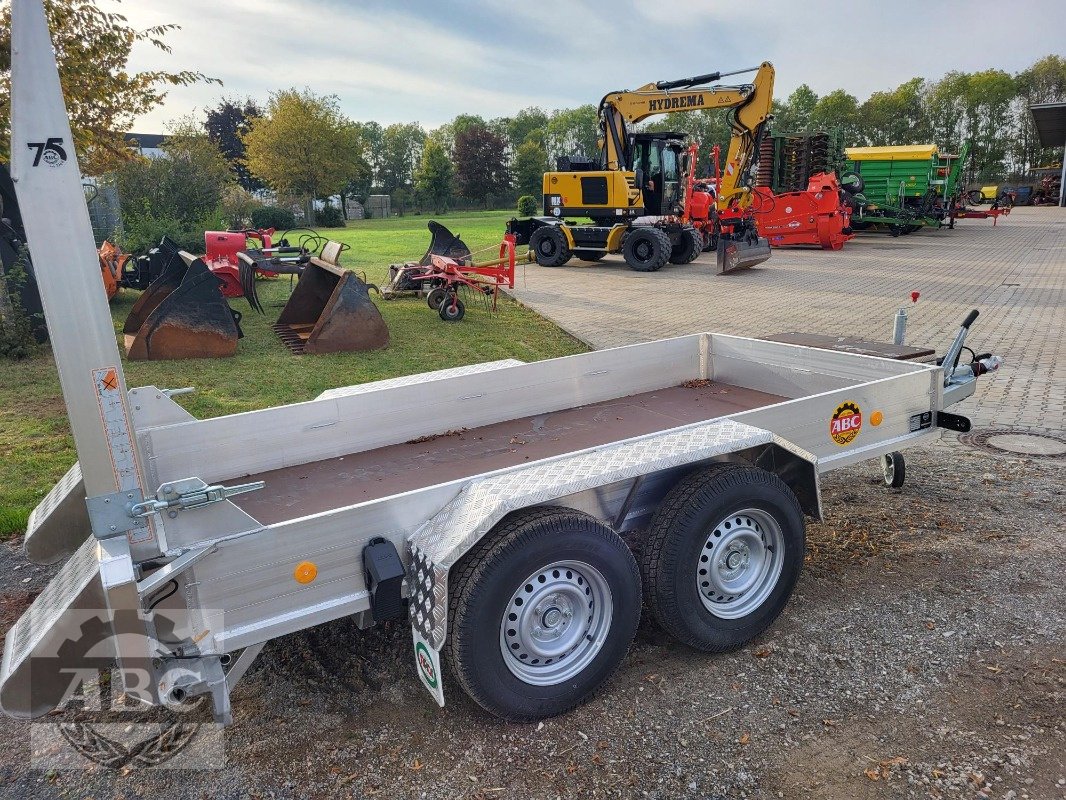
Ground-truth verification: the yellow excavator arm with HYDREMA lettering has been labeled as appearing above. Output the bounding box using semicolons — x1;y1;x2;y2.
599;62;774;208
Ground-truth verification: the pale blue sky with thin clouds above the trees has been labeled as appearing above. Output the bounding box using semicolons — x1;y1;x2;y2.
98;0;1066;133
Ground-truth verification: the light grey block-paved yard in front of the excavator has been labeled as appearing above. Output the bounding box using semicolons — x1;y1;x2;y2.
514;208;1066;431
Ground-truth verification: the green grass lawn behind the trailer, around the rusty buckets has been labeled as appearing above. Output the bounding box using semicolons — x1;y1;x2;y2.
0;211;587;538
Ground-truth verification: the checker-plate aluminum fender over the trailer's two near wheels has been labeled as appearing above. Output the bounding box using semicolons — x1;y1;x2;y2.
408;419;818;705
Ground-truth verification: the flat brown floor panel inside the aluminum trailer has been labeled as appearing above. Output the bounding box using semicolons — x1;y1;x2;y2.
233;381;788;525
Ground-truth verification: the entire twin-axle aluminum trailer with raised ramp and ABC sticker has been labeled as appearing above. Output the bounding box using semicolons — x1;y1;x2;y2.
0;0;997;721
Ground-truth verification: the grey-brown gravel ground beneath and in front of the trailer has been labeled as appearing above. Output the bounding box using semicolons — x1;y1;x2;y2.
0;437;1066;800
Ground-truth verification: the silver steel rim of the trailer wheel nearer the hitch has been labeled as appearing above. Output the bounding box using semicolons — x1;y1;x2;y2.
696;509;785;620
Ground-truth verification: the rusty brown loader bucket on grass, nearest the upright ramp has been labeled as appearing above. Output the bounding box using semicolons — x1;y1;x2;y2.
123;249;242;361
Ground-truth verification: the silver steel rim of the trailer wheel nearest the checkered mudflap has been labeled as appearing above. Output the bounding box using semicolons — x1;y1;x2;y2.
500;561;614;686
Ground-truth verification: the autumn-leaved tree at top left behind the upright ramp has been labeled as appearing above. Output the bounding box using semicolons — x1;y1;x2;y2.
0;0;221;175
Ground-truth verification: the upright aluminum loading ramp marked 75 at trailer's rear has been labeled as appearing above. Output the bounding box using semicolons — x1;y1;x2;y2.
11;0;143;507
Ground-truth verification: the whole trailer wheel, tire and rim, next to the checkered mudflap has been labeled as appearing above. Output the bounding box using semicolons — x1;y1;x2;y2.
445;508;641;722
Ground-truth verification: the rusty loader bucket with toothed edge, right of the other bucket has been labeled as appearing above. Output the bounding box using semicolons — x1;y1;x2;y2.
274;258;389;355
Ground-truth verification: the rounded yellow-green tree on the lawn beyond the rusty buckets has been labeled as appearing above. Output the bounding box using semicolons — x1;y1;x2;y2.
243;89;366;220
